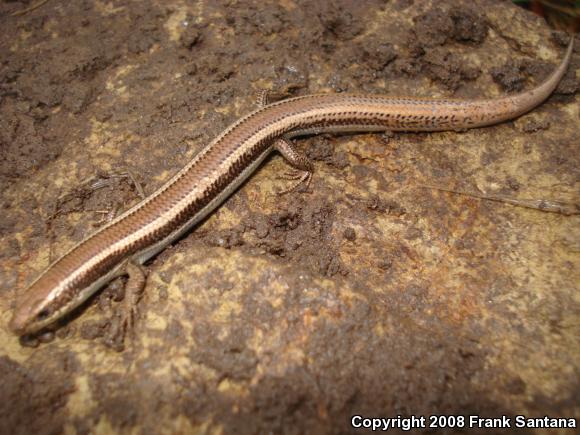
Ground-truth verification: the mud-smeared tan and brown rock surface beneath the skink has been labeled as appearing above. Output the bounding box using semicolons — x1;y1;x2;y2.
0;0;580;434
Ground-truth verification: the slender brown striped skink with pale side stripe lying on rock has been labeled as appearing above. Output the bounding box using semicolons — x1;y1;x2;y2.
10;38;573;335
